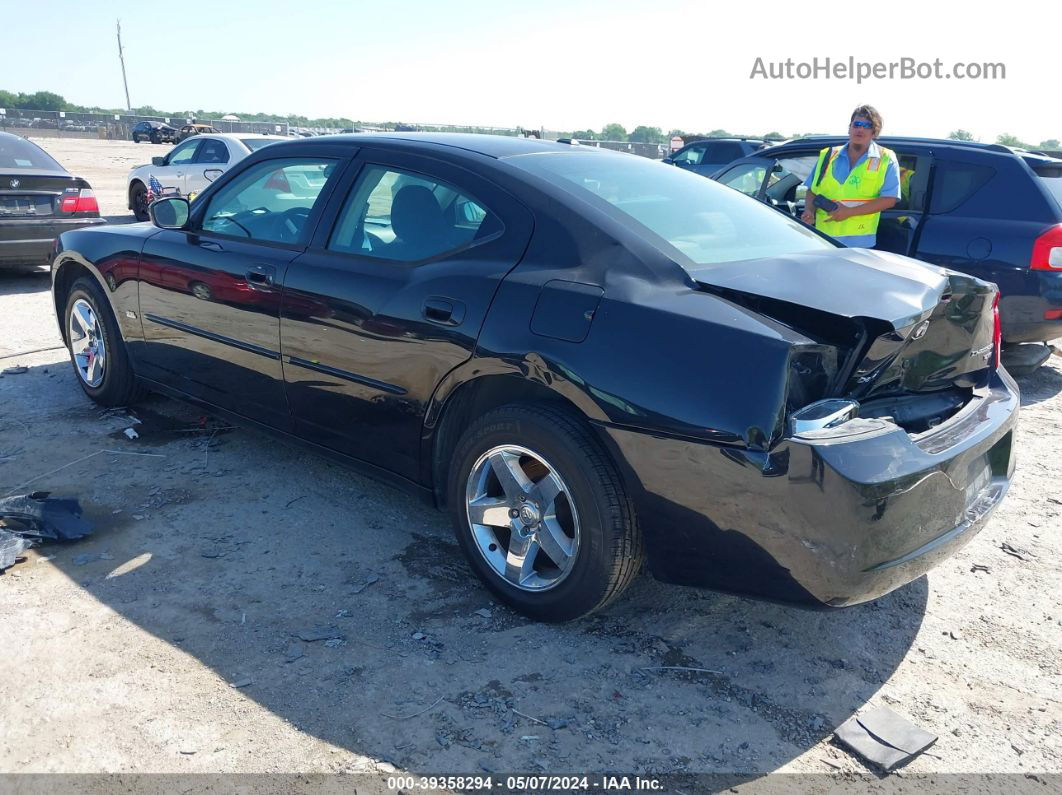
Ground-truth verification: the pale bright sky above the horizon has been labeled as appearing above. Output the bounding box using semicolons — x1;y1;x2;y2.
0;0;1062;143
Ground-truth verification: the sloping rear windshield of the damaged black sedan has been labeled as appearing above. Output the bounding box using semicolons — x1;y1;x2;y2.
508;152;836;265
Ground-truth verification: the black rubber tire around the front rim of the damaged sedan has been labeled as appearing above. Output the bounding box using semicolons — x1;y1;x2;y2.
63;276;147;407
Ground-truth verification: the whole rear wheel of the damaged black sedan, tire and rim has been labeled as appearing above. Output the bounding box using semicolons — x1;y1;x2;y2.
447;405;643;621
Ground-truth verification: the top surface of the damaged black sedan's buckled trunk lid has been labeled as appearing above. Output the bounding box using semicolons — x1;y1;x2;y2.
686;248;949;329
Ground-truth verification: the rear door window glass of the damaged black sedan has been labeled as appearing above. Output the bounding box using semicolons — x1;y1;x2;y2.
328;166;502;262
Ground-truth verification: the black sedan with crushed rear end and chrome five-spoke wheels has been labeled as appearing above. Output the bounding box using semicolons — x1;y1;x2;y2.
52;134;1018;620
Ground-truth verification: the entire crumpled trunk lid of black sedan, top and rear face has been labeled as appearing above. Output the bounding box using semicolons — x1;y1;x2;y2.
689;248;996;430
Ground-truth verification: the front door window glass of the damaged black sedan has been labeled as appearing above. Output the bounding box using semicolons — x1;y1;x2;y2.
202;157;337;245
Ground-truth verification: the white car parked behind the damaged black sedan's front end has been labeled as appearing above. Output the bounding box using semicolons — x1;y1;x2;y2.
127;134;288;221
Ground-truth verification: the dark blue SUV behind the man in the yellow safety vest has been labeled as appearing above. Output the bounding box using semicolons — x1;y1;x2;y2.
714;136;1062;375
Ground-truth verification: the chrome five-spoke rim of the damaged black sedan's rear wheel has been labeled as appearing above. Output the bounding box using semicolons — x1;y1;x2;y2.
465;445;579;591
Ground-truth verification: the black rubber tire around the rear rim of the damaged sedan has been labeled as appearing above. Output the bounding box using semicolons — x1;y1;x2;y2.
447;405;643;621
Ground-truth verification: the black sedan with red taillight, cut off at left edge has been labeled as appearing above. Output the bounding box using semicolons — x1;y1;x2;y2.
0;133;104;269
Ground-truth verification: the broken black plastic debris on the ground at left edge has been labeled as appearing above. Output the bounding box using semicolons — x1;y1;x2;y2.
0;491;92;571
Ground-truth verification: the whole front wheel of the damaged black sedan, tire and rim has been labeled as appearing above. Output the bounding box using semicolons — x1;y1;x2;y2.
63;277;144;405
